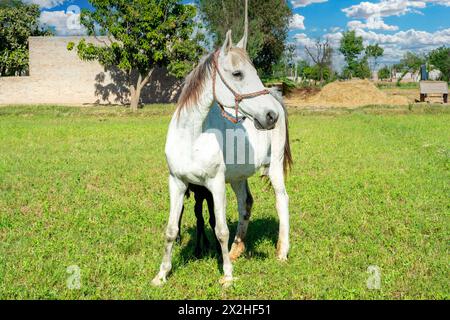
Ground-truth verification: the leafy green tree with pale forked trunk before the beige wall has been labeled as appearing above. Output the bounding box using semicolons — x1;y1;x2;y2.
68;0;204;111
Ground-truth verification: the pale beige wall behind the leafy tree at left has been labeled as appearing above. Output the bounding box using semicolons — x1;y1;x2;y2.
0;37;181;105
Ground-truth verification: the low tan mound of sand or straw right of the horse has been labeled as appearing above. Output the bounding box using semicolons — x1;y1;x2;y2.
287;80;408;108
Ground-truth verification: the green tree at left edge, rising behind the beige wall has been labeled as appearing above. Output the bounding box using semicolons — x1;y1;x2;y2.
0;0;51;76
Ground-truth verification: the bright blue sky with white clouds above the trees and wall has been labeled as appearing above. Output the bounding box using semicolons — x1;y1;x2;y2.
24;0;450;69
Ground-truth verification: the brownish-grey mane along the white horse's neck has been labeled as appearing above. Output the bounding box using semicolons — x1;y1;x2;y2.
177;53;214;114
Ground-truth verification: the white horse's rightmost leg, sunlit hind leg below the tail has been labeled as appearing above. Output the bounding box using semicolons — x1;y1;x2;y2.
269;165;289;261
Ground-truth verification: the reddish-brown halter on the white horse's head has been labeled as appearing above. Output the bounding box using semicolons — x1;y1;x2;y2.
213;49;270;124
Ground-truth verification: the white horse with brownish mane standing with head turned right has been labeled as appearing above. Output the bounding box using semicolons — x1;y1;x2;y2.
152;7;291;286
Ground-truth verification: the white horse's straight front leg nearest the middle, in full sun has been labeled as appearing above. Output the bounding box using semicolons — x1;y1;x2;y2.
207;174;233;287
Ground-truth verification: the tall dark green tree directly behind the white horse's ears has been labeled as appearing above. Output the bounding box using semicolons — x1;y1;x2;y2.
196;0;292;75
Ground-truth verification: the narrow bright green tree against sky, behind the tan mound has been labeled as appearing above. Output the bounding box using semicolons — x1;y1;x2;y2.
339;30;364;78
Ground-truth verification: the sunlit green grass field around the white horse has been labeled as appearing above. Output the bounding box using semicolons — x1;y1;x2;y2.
0;106;450;299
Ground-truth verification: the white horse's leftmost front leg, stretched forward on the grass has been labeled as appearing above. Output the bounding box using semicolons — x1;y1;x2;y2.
152;176;187;286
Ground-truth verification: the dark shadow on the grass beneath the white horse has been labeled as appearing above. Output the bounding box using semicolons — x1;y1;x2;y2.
174;218;278;272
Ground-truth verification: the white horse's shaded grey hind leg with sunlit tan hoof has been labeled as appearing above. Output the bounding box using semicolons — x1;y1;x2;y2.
230;180;253;261
